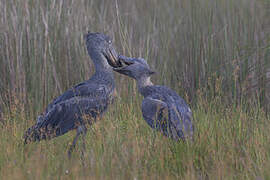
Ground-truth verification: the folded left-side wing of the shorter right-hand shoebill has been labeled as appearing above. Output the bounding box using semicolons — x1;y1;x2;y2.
142;97;169;135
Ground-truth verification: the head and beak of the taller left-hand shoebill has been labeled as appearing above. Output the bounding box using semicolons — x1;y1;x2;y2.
85;33;119;67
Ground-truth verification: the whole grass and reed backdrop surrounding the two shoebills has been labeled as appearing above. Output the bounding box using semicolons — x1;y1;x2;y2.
0;0;270;179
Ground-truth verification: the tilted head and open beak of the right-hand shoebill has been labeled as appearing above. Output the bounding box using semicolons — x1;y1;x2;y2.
113;55;155;80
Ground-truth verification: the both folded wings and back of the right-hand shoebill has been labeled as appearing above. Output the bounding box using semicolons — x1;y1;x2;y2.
142;95;193;140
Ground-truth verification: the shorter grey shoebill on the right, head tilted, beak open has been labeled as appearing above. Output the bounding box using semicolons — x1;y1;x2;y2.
114;56;193;140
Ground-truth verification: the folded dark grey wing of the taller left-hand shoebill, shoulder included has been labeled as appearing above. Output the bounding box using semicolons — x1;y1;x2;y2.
32;83;111;136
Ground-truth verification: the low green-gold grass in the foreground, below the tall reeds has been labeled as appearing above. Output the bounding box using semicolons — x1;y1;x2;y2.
0;99;270;179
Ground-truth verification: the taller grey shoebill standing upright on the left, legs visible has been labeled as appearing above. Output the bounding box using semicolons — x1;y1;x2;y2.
24;33;118;153
